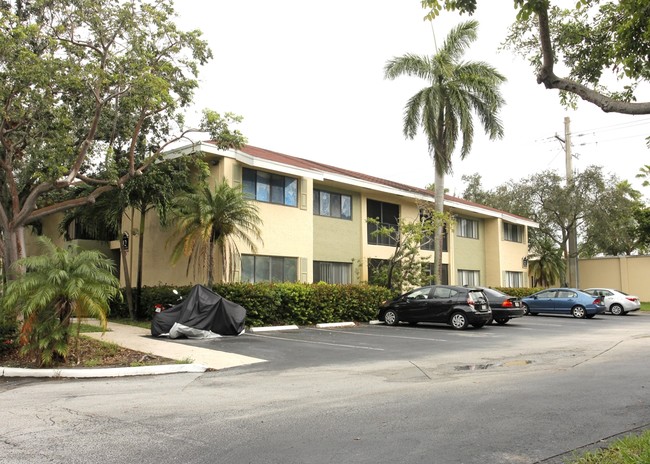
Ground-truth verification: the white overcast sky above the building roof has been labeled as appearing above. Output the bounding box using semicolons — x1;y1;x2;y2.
175;0;650;198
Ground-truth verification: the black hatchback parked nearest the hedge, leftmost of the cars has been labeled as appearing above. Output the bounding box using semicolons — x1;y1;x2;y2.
378;285;492;330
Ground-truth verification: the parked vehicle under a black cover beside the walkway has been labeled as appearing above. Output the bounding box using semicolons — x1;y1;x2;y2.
151;285;246;338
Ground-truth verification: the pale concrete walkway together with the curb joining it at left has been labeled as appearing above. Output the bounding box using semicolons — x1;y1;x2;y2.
0;322;265;377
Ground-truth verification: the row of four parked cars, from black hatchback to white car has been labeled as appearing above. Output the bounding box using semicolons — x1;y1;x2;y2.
377;285;641;330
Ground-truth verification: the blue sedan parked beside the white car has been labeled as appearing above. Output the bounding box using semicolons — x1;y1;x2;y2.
521;288;607;319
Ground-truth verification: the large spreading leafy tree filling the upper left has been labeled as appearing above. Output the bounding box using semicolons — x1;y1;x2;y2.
0;0;233;280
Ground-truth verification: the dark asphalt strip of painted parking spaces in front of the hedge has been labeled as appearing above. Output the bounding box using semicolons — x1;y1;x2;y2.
166;313;650;370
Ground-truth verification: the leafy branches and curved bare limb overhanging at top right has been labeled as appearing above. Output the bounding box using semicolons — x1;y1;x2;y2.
422;0;650;114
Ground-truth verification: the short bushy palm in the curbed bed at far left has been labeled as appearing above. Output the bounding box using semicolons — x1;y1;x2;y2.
2;237;120;365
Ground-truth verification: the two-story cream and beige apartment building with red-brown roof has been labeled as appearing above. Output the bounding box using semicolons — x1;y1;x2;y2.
111;142;537;287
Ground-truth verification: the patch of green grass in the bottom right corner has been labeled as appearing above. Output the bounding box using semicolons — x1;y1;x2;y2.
567;430;650;464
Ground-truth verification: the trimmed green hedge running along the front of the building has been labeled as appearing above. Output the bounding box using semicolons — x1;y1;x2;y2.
110;283;394;327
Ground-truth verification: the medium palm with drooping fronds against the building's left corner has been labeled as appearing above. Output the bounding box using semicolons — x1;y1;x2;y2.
171;180;262;287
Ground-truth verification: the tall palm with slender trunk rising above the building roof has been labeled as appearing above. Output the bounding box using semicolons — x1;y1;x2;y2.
384;21;506;283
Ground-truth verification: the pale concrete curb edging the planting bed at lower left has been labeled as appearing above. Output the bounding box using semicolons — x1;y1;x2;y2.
0;364;208;379
